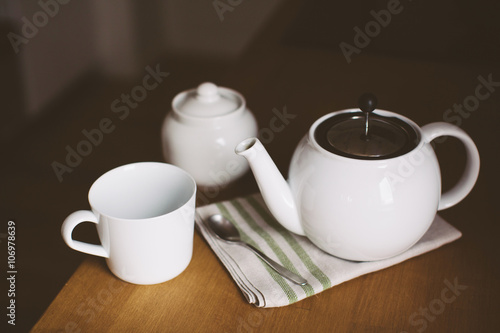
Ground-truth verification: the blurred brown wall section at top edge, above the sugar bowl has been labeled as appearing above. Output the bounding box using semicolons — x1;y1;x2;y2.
162;0;285;59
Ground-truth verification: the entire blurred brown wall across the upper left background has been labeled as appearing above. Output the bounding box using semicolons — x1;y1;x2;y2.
0;0;284;141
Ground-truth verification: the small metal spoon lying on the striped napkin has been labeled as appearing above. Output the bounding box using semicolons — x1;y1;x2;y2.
207;214;307;286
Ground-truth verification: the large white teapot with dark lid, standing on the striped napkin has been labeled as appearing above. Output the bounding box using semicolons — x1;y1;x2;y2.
235;94;479;261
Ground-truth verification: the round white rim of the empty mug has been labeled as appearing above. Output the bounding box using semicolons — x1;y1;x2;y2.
88;162;197;221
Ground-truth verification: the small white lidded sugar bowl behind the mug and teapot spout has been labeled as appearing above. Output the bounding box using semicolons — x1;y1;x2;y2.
162;82;258;187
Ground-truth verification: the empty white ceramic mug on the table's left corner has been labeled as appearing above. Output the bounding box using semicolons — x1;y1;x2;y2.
61;162;196;284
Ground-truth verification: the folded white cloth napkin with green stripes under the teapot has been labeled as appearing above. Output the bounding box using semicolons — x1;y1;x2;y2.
196;194;462;308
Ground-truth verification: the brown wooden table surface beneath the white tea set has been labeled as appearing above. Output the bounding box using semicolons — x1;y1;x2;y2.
33;1;500;332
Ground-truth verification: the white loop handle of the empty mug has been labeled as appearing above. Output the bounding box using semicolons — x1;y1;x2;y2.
61;210;109;258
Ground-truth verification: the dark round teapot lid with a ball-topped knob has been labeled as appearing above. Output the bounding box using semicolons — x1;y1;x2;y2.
314;93;420;160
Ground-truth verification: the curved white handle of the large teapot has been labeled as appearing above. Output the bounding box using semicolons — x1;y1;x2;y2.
422;122;480;210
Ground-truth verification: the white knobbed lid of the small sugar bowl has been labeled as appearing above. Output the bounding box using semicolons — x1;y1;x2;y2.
172;82;245;118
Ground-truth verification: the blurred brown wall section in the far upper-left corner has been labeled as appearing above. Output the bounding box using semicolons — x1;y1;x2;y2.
0;0;95;141
